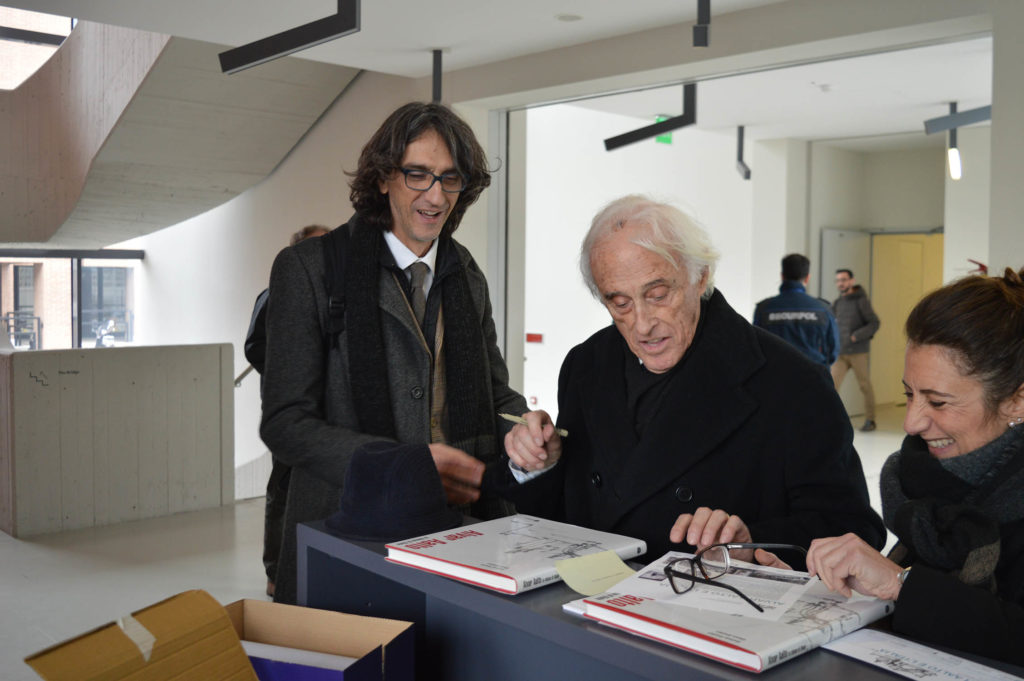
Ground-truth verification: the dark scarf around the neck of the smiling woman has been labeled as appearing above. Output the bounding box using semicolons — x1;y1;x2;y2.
882;428;1024;592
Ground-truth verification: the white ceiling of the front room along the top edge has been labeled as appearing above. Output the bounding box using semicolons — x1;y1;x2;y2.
8;0;782;78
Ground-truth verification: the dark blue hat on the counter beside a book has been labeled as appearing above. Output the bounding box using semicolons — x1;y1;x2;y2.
327;441;462;542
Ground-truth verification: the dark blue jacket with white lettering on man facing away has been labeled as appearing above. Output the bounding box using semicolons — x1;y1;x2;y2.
754;280;839;367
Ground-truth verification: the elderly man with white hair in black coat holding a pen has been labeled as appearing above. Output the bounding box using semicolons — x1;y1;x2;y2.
496;196;885;566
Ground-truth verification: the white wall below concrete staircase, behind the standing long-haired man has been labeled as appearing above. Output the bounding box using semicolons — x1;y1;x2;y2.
119;74;425;489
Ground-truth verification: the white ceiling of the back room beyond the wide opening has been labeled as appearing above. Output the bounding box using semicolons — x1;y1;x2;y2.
580;37;992;150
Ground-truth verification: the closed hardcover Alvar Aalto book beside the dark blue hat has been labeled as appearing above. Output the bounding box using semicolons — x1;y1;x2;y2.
387;514;647;594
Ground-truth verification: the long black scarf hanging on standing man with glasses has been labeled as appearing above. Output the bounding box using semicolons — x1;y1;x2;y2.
342;220;495;452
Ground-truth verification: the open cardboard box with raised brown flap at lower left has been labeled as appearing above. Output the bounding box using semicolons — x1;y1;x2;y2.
25;591;415;681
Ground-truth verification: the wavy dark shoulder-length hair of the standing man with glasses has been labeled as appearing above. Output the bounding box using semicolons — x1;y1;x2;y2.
346;101;490;236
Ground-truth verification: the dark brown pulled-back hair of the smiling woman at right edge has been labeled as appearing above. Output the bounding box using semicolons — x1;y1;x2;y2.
906;267;1024;415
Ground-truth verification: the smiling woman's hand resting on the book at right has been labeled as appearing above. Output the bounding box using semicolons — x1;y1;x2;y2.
807;533;902;600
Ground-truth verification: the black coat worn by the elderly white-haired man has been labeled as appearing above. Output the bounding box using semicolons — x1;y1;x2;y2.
491;291;885;566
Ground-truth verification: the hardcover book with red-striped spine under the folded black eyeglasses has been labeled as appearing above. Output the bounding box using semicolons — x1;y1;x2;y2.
583;551;893;672
